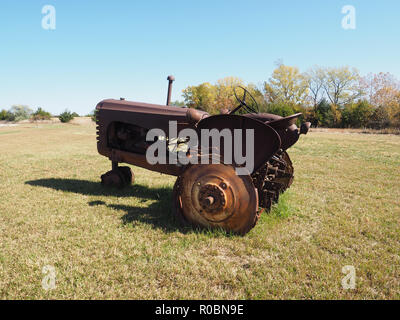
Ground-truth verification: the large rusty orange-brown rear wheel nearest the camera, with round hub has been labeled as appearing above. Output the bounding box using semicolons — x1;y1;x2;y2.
173;164;259;235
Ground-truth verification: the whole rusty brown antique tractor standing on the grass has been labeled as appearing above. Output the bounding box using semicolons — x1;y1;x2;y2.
96;76;310;235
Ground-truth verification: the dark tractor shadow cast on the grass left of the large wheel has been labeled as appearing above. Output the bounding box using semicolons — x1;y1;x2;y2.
25;178;196;233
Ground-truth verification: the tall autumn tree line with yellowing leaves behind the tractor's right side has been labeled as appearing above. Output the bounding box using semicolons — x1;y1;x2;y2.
180;63;400;129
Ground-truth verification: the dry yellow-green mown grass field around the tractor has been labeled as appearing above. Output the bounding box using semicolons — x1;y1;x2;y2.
0;124;400;299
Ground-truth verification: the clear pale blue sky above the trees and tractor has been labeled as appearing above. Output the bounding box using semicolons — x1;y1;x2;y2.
0;0;400;114
